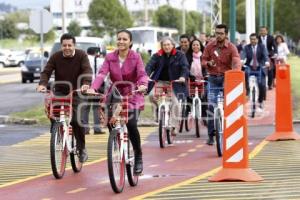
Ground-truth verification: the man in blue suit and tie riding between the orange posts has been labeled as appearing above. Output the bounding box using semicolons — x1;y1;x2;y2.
242;33;270;109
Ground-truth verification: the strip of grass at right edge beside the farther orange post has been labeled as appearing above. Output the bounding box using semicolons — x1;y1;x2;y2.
288;56;300;120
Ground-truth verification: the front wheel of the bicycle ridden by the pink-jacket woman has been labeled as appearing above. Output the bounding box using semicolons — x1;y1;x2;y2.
107;130;125;193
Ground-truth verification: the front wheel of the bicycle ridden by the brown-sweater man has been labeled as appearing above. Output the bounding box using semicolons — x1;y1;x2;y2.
50;122;68;179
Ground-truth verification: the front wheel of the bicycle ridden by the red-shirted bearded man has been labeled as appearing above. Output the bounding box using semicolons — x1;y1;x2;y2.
215;109;223;157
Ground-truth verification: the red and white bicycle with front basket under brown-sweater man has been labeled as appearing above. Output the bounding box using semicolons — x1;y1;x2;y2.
45;91;82;179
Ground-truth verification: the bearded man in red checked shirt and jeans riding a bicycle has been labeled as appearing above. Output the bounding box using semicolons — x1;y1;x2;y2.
202;24;241;145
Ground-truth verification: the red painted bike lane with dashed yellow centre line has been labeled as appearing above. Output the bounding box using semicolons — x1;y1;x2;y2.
0;92;274;200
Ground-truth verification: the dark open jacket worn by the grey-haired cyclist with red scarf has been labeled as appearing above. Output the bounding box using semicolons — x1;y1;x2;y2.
146;49;189;96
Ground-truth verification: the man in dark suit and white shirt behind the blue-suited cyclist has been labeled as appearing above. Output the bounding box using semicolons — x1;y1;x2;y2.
259;26;277;90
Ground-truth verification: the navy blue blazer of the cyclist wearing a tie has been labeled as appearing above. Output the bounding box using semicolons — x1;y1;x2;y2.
242;43;269;75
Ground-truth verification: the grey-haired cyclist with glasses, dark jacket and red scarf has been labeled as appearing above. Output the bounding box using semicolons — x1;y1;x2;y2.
146;37;189;135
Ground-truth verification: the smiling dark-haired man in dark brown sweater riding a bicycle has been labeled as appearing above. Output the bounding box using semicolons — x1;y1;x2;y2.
37;33;92;163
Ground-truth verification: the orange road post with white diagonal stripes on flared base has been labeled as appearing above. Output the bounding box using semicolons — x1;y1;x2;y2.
208;70;263;181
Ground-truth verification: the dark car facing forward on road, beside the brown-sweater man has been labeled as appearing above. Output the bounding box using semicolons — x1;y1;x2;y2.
21;51;48;83
